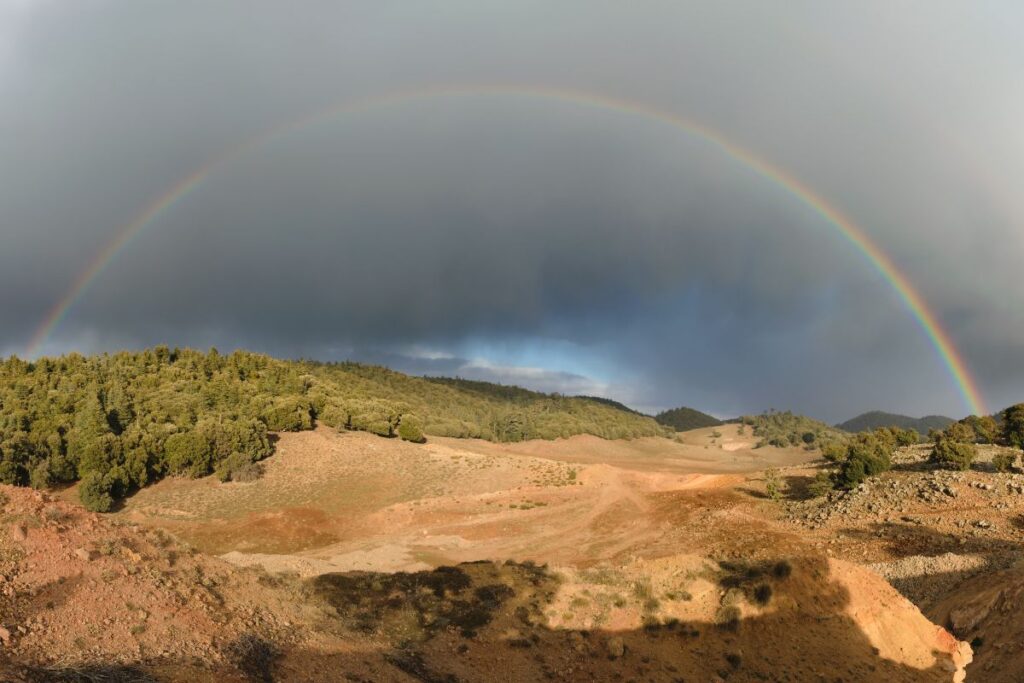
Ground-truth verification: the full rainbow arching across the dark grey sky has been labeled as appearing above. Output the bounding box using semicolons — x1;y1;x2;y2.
27;85;986;415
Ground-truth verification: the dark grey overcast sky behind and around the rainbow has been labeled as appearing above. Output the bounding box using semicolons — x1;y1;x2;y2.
0;0;1024;421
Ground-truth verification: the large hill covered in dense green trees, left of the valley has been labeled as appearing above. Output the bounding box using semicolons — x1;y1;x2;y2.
0;347;664;510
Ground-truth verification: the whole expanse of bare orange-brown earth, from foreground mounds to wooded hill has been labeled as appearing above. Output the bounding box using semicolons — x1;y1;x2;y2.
0;425;971;682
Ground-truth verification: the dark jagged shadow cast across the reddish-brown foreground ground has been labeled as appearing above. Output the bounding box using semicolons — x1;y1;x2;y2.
0;558;952;683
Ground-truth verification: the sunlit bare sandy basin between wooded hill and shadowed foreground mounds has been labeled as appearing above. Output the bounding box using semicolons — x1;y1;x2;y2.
120;427;809;574
